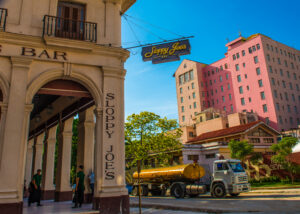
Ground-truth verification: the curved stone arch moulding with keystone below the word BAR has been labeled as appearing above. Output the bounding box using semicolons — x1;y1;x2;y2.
26;68;102;107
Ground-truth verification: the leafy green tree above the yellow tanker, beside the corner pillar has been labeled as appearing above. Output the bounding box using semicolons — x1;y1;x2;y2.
125;111;181;167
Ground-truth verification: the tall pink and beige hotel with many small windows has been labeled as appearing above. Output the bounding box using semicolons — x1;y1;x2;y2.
174;34;300;131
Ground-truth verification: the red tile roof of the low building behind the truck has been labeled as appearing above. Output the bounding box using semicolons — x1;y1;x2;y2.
187;121;264;143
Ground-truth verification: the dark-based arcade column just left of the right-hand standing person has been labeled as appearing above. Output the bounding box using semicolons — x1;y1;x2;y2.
55;118;74;201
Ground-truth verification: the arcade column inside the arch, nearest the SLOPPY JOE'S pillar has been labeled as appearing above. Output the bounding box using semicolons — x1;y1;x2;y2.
77;106;95;203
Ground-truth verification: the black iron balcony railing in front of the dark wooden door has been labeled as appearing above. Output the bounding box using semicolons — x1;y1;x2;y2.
43;15;97;42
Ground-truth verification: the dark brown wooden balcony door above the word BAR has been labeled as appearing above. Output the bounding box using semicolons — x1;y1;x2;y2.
56;2;85;40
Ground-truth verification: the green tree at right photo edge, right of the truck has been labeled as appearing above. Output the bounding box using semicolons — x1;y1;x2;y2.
271;137;300;183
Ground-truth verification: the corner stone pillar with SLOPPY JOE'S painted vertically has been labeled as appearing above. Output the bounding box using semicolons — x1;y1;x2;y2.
94;67;129;214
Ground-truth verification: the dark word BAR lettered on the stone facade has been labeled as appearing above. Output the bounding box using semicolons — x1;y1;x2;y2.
21;47;67;61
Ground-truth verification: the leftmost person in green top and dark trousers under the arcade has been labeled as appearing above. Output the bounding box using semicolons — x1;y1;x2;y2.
28;169;42;207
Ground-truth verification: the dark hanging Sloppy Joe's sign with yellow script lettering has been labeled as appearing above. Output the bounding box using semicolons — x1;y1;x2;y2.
142;39;191;64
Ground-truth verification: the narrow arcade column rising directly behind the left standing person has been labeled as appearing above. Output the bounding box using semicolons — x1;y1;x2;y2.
32;133;45;175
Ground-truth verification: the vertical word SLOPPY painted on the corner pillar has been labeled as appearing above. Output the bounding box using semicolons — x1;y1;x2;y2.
105;93;115;138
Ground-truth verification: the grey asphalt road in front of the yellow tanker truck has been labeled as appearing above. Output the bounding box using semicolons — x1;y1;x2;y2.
130;192;300;214
